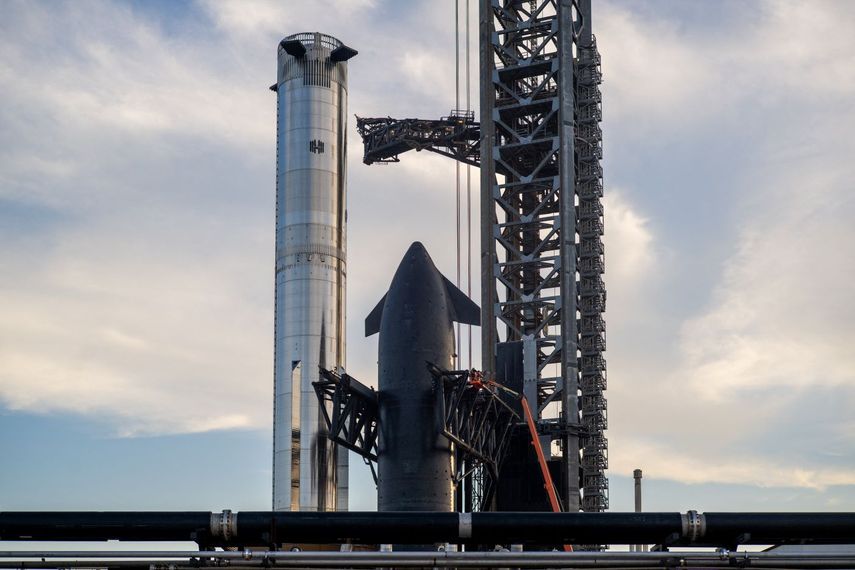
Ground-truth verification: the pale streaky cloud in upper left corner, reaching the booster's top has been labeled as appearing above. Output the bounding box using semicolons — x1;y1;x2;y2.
3;5;269;149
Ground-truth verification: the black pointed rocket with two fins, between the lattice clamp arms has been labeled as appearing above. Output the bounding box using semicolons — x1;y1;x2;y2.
365;242;481;511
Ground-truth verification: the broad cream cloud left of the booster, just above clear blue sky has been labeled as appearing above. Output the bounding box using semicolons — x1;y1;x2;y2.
0;219;270;434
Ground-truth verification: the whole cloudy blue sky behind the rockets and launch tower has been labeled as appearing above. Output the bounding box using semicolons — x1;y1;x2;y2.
0;0;855;511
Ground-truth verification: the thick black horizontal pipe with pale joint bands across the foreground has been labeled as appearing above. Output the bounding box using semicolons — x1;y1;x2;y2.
0;511;855;548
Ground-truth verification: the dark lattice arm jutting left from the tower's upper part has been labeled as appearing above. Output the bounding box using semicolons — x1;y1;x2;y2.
356;111;481;166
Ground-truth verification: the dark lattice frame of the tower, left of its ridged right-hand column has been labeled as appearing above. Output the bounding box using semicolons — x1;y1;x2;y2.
481;0;601;512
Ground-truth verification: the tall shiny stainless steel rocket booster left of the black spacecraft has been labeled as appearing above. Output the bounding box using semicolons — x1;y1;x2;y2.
271;33;356;511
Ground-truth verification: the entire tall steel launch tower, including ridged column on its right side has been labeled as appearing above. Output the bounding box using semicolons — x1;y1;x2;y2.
480;0;608;511
